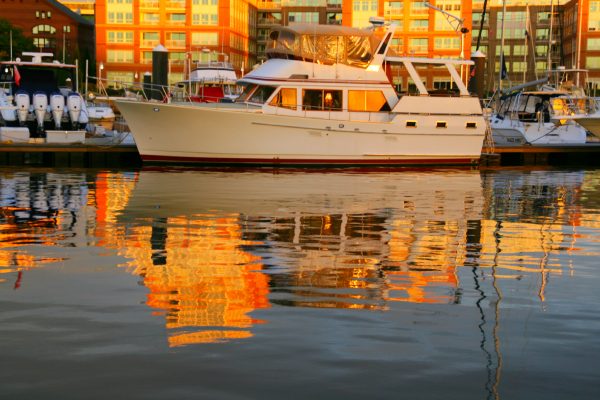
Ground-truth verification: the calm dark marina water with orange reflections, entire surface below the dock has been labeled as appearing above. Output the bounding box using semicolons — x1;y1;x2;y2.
0;168;600;399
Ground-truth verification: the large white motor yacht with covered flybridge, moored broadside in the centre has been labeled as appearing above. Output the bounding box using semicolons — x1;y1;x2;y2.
116;25;486;165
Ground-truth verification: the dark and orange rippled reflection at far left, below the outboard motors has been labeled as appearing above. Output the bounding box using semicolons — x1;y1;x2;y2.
0;171;87;289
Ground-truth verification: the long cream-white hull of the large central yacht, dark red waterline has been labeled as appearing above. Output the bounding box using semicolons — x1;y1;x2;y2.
118;102;485;165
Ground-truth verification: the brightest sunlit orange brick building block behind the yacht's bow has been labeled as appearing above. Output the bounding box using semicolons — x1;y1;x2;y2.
95;0;256;86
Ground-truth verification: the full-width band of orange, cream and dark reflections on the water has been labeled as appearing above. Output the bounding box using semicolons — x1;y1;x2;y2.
0;169;600;350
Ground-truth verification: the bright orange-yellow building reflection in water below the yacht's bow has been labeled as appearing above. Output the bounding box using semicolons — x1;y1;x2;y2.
116;216;269;346
